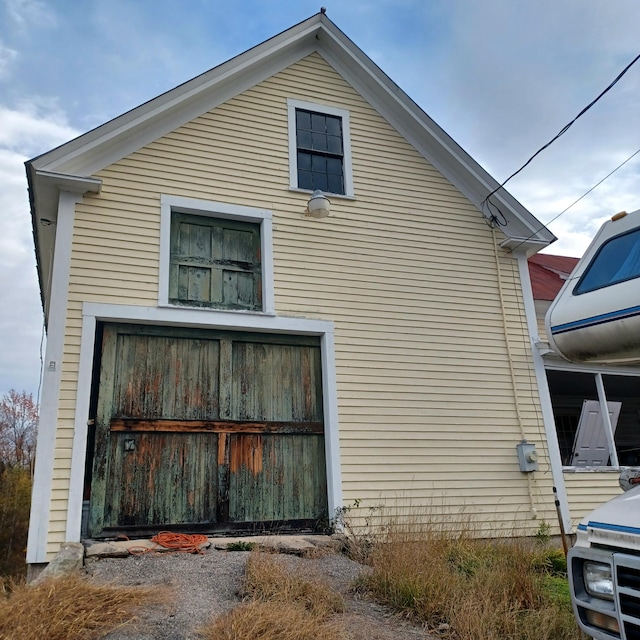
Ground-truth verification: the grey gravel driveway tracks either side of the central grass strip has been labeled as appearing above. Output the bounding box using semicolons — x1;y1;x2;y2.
86;549;437;640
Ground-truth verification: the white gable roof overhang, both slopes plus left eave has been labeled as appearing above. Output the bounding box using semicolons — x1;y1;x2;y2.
26;13;556;308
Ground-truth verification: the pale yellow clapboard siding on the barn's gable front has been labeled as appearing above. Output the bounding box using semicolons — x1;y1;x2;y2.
37;54;553;546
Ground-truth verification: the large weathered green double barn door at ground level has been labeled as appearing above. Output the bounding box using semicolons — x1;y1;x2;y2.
90;325;328;536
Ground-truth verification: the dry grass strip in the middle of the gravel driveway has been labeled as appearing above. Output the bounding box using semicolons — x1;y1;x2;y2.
201;553;344;640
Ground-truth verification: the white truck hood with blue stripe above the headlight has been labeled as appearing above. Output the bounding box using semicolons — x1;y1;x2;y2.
578;486;640;550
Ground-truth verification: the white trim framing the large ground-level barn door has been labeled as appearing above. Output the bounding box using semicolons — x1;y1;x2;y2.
66;302;343;542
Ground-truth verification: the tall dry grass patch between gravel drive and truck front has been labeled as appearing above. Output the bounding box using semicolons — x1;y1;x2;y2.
360;530;580;640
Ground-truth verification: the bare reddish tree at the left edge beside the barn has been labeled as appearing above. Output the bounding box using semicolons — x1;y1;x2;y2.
0;389;38;469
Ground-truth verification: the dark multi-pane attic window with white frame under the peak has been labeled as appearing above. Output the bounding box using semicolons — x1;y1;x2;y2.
288;100;353;196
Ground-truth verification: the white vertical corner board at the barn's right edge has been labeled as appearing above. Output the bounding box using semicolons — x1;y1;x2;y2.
512;249;573;533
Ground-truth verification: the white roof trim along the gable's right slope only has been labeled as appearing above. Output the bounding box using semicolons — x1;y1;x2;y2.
318;29;555;246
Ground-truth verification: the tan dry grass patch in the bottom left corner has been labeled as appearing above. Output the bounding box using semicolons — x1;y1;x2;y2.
0;576;162;640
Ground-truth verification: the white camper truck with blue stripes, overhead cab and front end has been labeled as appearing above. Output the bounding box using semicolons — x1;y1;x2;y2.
545;210;640;640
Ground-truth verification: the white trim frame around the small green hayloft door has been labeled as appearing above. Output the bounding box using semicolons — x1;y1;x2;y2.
158;194;275;315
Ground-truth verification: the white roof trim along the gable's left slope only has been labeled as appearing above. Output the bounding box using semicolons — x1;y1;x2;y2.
32;16;322;175
